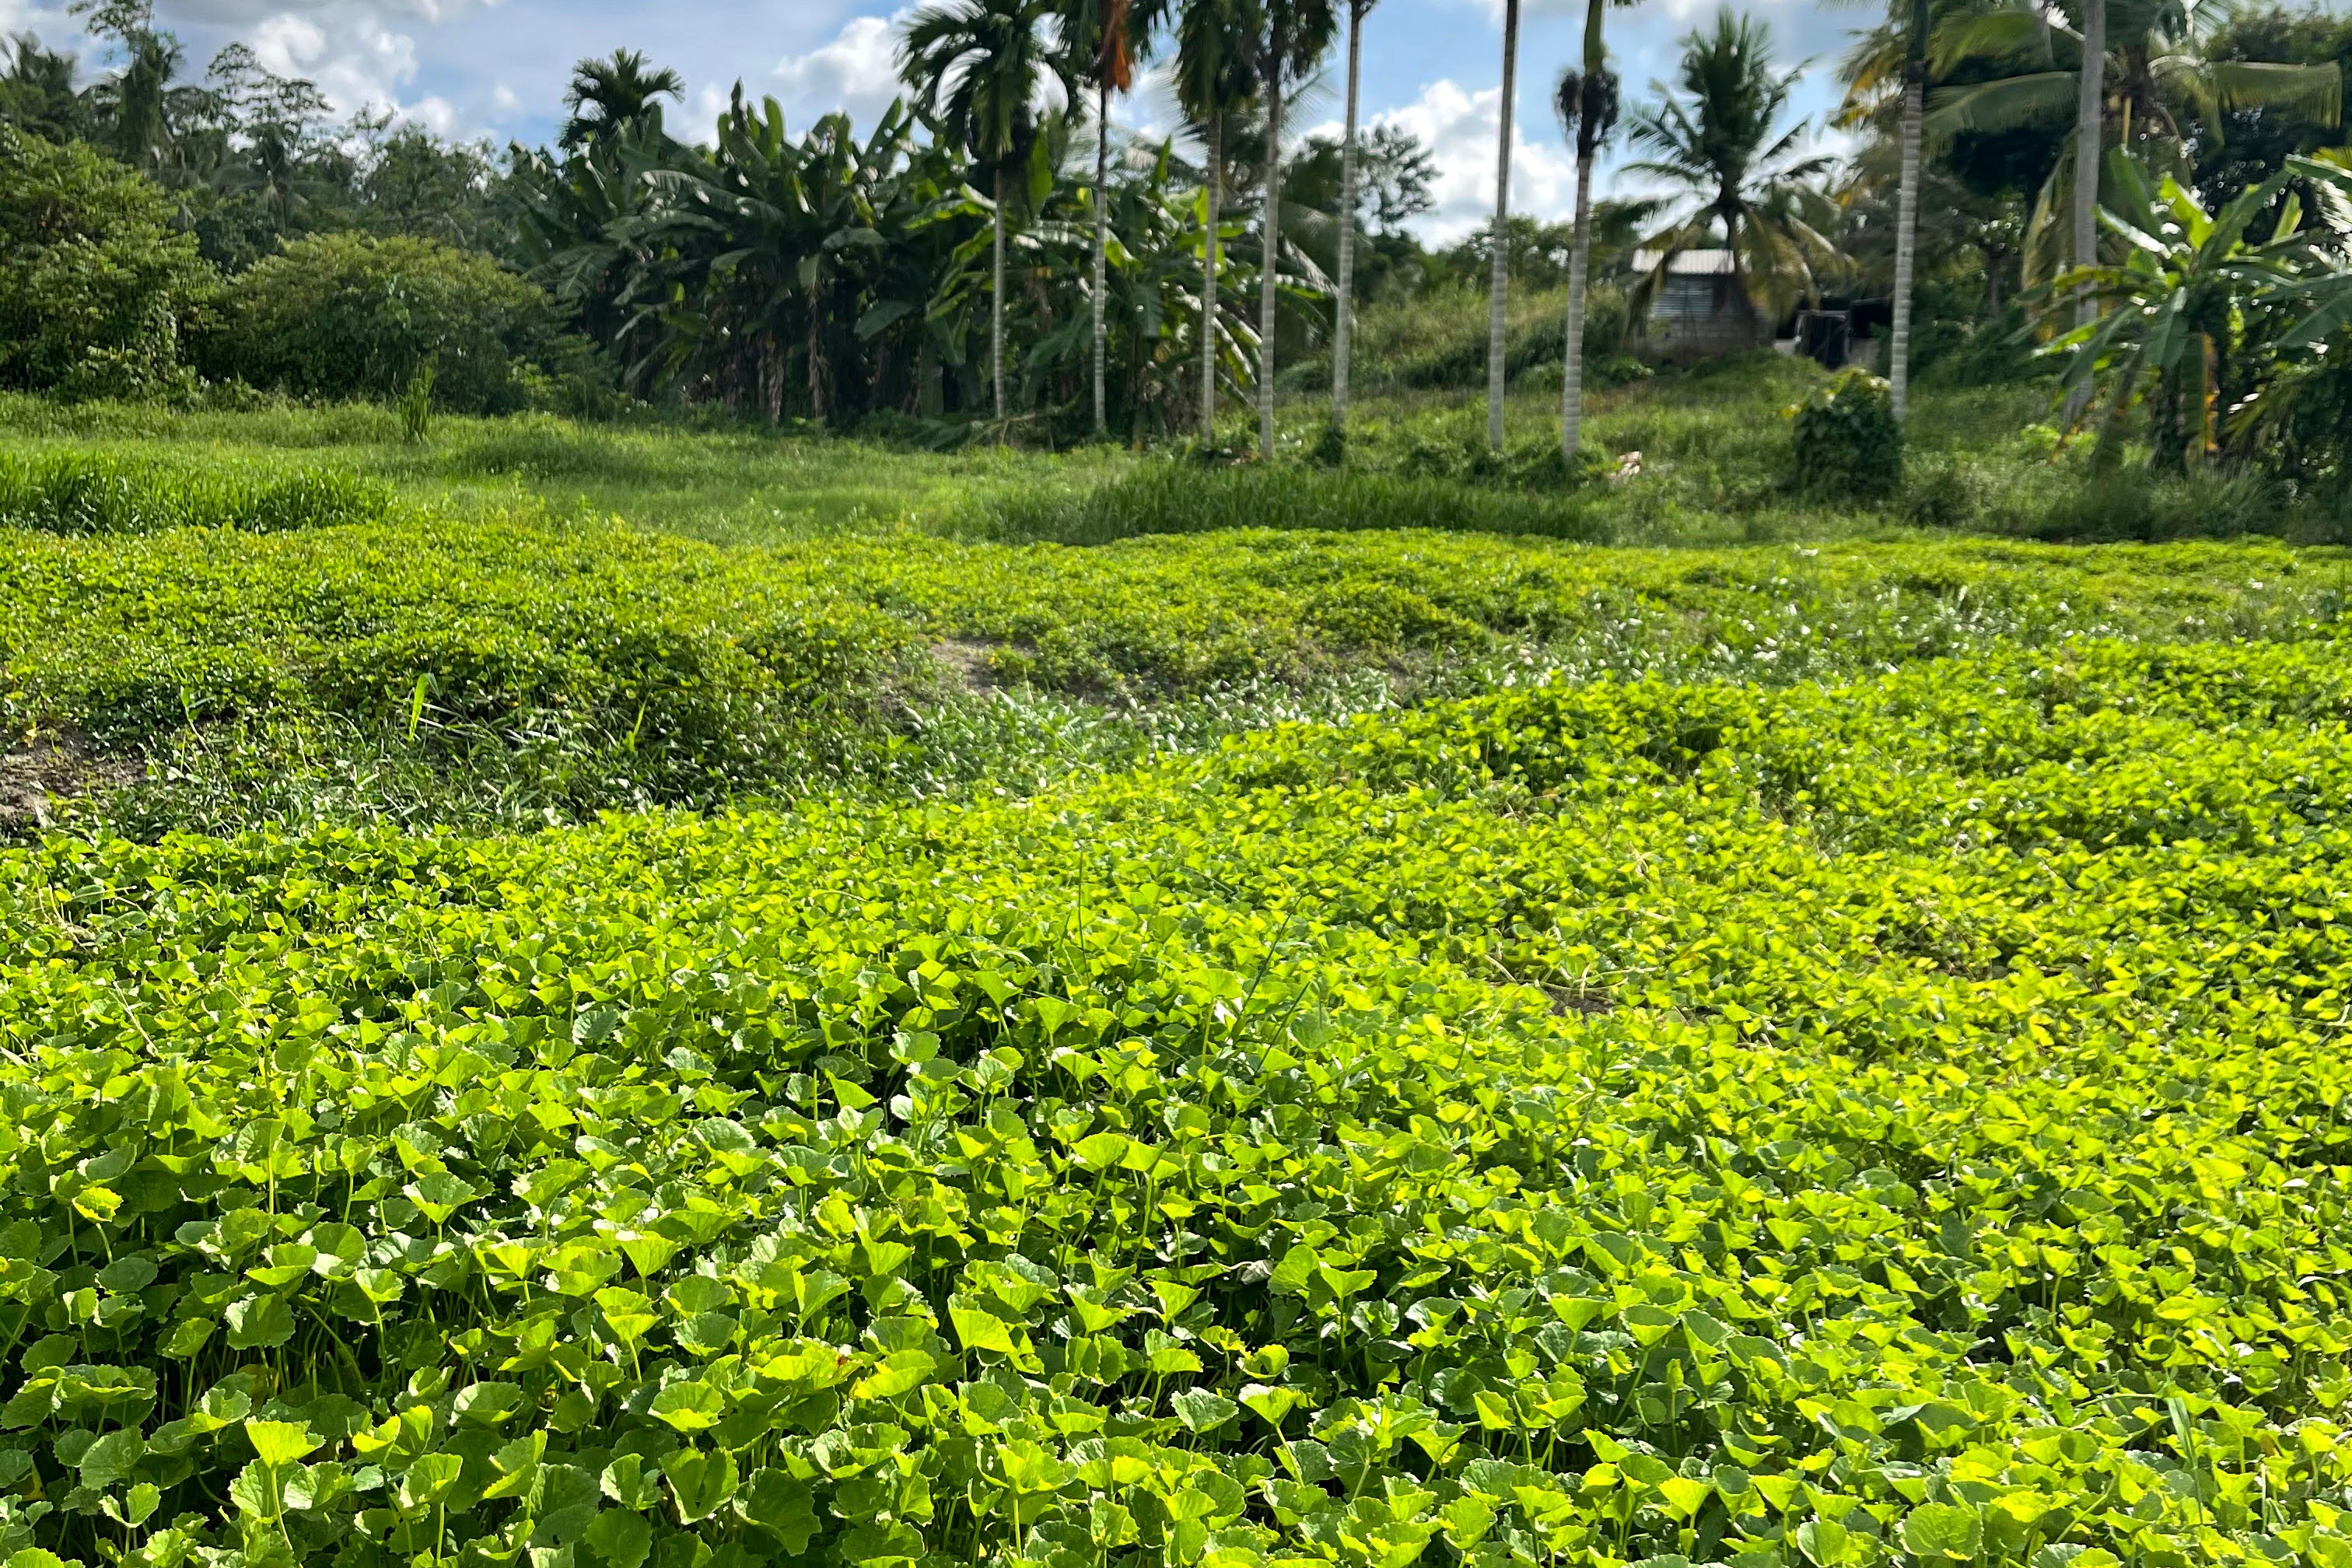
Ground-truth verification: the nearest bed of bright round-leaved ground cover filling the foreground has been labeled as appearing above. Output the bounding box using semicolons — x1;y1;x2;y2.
0;637;2352;1568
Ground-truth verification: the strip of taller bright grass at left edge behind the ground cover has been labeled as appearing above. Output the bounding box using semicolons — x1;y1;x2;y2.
0;451;393;534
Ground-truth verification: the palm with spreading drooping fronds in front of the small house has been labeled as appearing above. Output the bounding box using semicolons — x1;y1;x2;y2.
1626;9;1842;350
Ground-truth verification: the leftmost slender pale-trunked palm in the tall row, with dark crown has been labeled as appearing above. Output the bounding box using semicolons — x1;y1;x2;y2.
898;0;1068;423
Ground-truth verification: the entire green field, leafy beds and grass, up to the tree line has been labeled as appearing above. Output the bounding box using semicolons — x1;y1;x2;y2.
0;367;2352;1568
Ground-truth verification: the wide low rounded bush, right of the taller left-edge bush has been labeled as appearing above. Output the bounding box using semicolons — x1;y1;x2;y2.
205;235;583;414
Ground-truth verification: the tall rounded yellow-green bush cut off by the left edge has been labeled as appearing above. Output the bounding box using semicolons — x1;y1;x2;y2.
0;124;219;397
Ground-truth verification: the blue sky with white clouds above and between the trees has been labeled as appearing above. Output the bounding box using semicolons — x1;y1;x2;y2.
0;0;2345;240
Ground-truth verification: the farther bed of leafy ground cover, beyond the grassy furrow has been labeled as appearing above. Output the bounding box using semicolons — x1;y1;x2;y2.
0;493;2343;832
